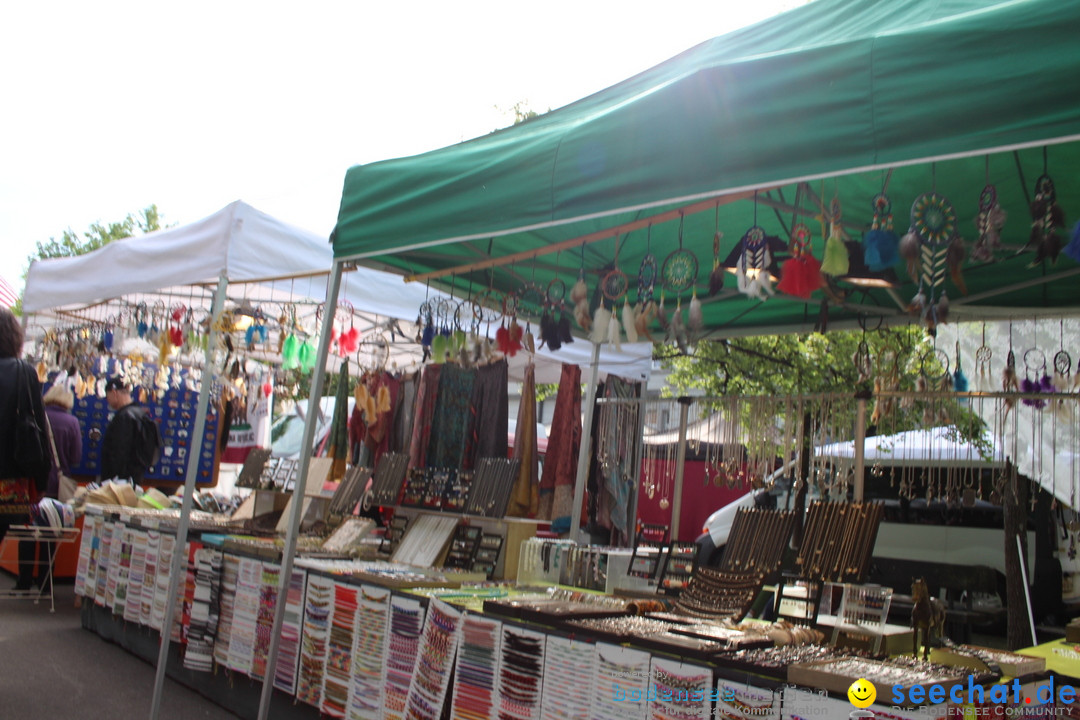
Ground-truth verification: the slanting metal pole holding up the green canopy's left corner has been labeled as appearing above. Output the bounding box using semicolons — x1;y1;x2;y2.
258;261;342;720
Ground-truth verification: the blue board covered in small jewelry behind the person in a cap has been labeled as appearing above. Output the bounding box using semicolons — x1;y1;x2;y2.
61;363;220;488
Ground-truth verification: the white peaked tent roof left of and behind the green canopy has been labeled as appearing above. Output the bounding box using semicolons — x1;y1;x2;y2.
23;200;652;382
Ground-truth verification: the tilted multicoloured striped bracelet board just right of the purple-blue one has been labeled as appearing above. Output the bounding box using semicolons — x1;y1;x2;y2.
405;599;462;720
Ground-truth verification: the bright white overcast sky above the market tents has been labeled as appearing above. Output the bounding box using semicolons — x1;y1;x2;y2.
0;0;804;290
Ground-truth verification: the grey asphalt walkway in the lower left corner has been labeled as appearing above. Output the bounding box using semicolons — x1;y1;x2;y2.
0;571;237;720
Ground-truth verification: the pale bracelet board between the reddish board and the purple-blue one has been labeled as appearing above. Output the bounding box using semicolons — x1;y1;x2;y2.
346;585;390;720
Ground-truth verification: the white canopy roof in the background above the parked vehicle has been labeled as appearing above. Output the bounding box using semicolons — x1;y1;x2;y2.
814;427;1004;467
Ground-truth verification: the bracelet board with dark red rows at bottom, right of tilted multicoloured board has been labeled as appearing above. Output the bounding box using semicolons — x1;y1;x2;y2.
450;614;502;720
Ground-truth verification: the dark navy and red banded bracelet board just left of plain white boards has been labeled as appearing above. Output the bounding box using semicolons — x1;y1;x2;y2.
498;625;544;720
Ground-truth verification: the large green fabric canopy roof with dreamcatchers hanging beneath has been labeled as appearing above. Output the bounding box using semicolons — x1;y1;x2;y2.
334;0;1080;335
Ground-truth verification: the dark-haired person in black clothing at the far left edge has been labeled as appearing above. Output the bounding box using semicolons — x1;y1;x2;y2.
0;308;49;590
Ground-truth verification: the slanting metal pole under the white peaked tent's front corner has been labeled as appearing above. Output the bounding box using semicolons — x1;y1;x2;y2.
150;272;229;720
